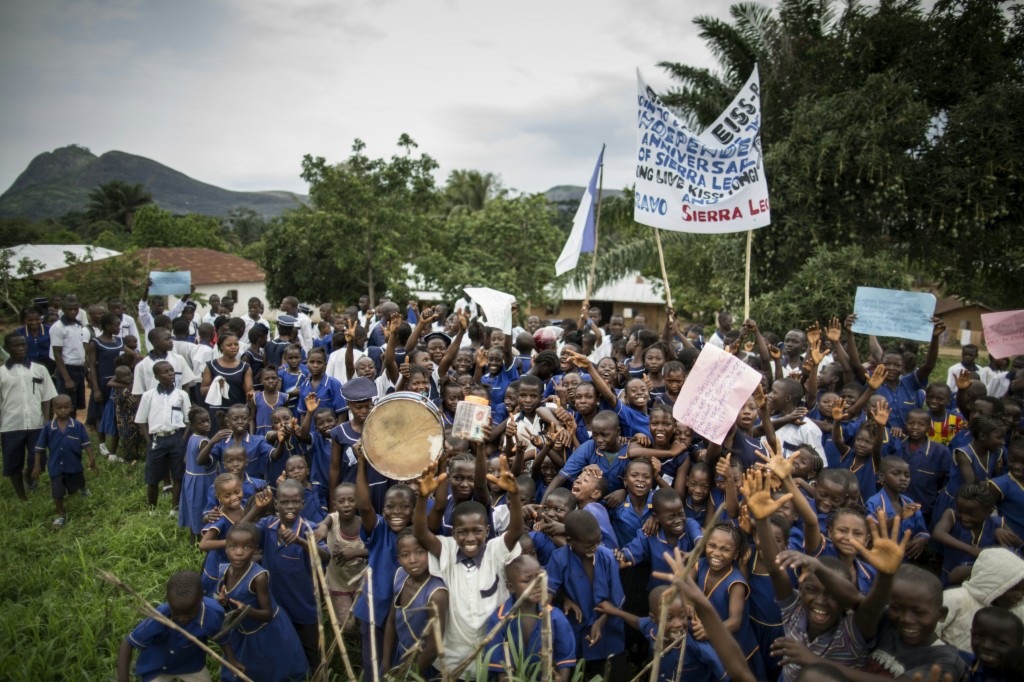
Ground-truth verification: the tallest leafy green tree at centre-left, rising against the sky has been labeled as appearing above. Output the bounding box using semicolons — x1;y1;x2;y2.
254;134;440;302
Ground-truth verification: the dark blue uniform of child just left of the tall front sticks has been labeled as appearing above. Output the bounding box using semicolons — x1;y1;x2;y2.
256;516;327;625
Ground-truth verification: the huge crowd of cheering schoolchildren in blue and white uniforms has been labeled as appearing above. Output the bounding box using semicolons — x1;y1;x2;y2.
0;288;1024;682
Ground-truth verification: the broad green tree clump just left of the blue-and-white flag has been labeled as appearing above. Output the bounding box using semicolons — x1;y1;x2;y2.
415;195;565;303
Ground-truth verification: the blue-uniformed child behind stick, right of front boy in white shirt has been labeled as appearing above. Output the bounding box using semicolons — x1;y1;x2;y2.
484;556;577;682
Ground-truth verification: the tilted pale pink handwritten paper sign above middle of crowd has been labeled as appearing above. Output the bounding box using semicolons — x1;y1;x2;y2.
672;344;761;445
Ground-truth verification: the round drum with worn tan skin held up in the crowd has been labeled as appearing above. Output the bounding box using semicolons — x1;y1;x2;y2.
362;391;444;480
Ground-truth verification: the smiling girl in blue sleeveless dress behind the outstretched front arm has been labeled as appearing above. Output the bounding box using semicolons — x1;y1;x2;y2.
687;521;765;680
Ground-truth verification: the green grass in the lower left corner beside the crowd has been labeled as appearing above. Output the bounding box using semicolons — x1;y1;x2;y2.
0;454;197;680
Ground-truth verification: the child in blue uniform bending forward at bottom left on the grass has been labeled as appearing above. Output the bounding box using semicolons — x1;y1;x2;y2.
118;570;227;682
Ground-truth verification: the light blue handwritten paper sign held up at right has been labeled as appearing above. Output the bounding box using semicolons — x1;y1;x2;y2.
853;287;935;341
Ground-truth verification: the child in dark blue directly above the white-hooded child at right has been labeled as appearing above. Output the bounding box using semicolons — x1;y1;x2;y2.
932;483;1007;587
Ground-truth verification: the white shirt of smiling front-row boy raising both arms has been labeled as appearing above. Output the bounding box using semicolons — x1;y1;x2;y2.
429;536;520;669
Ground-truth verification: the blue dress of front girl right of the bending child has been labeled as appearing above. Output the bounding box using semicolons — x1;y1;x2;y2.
217;561;309;682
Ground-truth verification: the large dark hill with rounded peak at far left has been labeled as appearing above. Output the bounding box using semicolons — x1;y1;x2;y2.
0;145;307;219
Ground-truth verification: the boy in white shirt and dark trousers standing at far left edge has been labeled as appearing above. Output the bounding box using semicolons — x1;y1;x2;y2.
0;334;57;500
